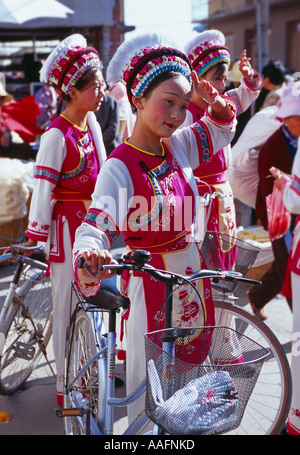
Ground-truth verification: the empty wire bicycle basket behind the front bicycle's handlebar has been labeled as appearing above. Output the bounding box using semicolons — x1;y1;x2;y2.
201;231;260;292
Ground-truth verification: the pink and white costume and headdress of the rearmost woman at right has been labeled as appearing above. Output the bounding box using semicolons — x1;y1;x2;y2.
184;29;263;269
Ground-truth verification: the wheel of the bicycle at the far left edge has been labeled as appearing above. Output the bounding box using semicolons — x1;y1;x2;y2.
0;271;53;395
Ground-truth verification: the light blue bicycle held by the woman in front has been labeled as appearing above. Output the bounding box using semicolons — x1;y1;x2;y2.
57;251;288;435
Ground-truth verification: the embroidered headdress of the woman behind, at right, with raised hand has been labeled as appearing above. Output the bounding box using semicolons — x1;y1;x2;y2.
185;30;230;76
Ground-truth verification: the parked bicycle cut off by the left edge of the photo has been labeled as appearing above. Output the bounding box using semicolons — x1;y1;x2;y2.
0;245;55;395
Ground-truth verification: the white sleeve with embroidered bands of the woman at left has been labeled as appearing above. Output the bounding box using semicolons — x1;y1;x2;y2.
27;128;66;242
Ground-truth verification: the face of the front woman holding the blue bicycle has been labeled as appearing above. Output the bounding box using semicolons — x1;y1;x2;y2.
134;74;192;138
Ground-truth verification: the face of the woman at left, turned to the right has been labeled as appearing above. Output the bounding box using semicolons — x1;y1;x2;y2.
73;70;105;112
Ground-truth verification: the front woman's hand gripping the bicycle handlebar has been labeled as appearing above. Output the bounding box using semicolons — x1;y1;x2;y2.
77;250;114;281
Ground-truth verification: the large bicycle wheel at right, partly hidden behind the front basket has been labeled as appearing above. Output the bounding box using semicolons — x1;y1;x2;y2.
214;299;292;435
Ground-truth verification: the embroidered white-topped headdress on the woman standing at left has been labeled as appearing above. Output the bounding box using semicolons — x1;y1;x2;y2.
40;34;101;95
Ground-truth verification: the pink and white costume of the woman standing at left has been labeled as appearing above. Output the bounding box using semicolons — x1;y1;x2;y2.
27;113;106;403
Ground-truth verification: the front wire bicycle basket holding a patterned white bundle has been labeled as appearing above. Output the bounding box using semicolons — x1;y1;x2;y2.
145;326;269;435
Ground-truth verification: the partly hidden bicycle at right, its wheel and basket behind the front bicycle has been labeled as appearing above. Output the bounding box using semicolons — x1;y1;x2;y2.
201;231;292;435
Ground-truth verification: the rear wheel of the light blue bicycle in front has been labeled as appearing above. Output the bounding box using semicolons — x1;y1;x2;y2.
64;309;106;435
